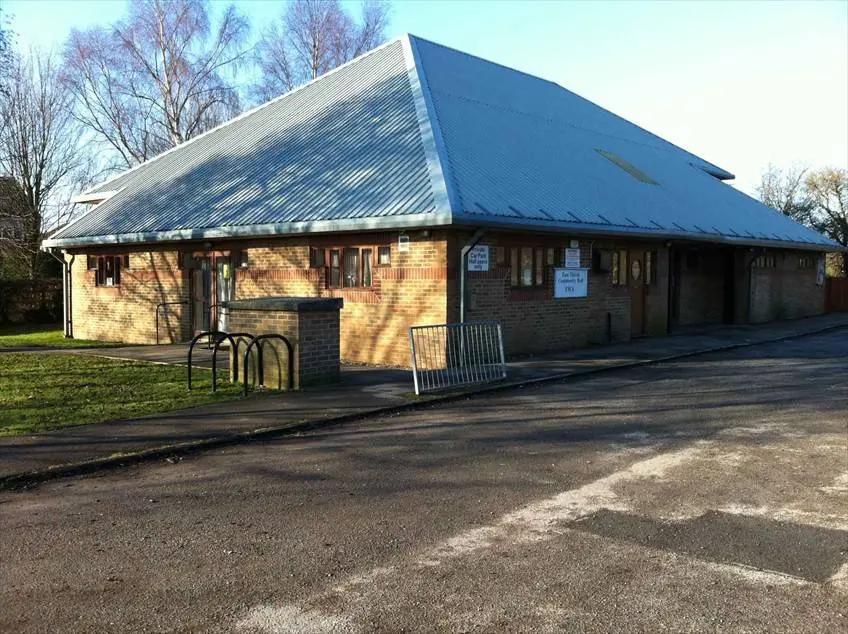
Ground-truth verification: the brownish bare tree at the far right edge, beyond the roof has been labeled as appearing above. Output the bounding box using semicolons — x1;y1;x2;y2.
805;167;848;273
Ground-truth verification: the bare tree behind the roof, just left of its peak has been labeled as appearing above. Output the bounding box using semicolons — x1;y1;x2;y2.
252;0;391;101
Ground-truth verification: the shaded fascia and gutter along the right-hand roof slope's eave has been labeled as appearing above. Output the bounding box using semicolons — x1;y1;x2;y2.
453;215;843;252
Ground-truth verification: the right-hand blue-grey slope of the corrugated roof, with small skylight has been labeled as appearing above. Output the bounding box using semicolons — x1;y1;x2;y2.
415;34;833;245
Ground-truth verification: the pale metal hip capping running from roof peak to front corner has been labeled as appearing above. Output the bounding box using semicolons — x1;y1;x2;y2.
400;33;460;213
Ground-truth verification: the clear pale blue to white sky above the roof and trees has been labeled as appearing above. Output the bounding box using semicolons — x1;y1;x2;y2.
6;0;848;192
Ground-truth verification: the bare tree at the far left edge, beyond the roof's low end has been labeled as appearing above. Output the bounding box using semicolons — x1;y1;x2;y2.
0;52;89;278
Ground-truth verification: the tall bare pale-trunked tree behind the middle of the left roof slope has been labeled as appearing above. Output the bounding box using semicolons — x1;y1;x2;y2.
63;0;249;166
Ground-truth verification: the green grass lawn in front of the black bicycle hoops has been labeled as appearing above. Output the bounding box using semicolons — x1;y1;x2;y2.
0;352;241;436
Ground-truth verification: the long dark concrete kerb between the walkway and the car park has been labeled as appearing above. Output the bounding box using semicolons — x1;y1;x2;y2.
0;324;848;491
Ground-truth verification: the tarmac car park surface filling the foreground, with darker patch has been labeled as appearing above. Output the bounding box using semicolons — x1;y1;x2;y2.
0;330;848;633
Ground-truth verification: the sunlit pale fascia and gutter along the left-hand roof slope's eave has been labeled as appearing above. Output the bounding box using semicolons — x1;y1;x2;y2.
42;213;451;248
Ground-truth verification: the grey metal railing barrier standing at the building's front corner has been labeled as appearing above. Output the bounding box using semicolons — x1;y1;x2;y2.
409;321;506;394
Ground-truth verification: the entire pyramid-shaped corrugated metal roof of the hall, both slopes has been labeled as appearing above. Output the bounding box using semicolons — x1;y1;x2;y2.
46;36;834;246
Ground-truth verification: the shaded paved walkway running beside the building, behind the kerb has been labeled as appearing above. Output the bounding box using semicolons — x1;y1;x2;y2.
0;313;848;476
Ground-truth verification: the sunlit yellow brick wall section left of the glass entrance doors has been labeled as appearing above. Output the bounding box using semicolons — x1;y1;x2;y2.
68;251;190;344
